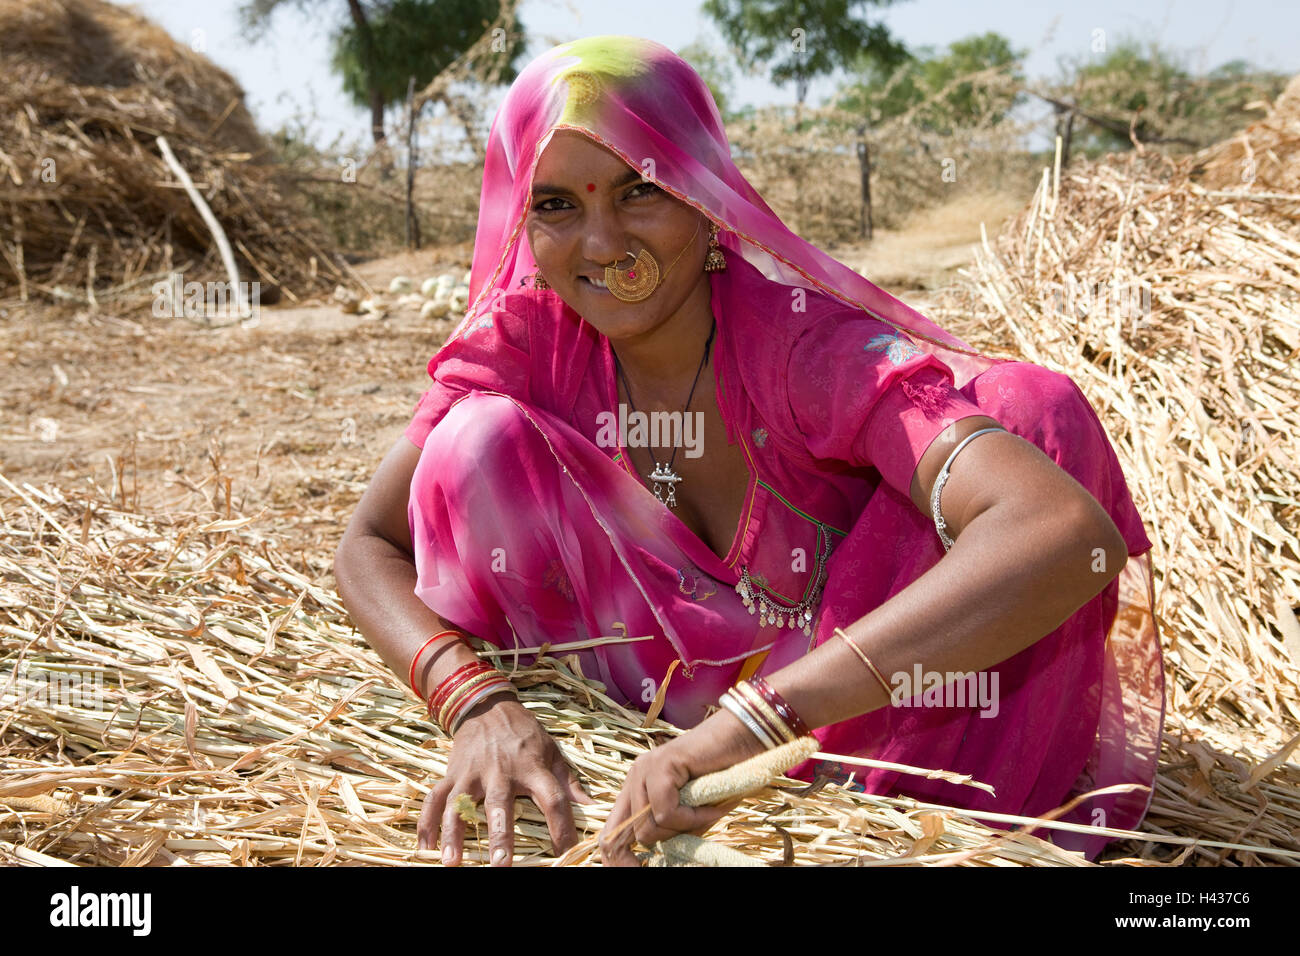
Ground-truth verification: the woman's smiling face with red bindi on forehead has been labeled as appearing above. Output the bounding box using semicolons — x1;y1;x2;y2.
524;130;709;339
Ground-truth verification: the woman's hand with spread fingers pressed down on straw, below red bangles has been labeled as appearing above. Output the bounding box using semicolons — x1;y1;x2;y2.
416;695;595;866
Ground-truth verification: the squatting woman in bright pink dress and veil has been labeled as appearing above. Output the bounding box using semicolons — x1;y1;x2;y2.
337;36;1164;865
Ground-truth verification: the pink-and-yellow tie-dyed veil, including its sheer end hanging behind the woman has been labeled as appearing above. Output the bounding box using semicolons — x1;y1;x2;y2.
430;36;1162;858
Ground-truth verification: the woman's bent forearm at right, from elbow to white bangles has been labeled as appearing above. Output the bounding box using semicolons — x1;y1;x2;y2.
768;497;1128;727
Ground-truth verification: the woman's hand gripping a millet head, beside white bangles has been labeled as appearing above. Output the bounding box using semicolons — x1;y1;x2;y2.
598;710;764;866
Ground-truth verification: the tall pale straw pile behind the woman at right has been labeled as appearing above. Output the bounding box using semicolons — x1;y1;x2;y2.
928;91;1300;861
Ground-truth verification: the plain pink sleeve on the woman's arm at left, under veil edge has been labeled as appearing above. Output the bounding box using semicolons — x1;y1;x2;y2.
404;297;530;449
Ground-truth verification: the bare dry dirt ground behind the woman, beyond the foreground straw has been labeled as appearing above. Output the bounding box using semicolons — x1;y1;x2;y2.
0;209;1001;583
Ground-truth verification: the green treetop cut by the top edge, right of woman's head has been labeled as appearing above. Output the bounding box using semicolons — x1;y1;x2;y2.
702;0;907;122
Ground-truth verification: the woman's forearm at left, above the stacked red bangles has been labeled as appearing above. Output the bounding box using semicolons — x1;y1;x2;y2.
334;532;477;700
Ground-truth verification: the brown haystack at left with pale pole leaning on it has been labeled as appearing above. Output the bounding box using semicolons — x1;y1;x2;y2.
0;0;343;306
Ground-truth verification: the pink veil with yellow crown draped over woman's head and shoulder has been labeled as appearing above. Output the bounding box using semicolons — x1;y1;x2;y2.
451;36;995;388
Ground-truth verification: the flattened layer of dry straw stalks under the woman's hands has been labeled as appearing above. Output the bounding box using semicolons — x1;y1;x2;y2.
0;475;1300;866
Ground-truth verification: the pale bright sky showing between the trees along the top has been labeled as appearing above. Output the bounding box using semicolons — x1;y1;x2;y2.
124;0;1300;151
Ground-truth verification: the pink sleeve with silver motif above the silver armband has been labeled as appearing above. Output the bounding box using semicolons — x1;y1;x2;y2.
788;312;985;496
